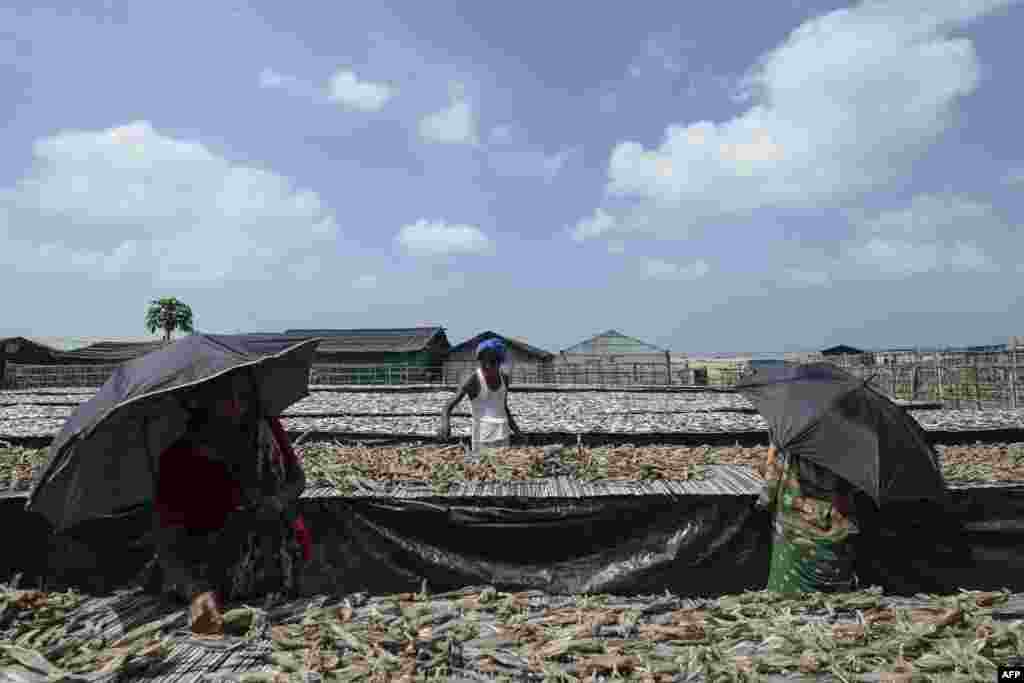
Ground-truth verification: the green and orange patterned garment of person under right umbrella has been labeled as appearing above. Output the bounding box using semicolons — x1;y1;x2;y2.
760;448;858;594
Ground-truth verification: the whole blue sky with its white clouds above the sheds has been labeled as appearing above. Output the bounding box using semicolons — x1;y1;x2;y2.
0;0;1024;353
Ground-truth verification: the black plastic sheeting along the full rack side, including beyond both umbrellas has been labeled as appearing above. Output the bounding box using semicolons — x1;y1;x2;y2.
6;486;1024;596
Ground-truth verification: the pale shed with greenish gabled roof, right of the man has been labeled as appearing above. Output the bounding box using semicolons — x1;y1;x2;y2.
554;330;673;385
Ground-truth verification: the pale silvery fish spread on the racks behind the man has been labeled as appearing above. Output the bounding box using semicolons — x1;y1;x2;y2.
8;389;1024;437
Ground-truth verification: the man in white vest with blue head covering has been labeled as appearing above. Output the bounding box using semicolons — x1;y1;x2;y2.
438;339;520;454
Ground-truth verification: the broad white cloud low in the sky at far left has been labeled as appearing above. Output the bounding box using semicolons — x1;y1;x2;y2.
0;121;338;283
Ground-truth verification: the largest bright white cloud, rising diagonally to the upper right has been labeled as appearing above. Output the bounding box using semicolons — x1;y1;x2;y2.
573;0;1009;240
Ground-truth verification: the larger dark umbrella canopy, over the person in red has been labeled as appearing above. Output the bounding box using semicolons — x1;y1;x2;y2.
26;334;319;531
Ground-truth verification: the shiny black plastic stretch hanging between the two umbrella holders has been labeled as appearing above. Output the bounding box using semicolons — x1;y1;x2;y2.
303;496;768;595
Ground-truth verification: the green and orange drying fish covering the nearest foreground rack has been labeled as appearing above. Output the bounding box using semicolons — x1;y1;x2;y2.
0;585;1024;683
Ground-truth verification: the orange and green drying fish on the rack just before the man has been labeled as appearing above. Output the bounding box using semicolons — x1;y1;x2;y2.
6;441;1024;494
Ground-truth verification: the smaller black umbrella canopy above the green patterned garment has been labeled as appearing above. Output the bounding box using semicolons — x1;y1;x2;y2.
736;362;946;505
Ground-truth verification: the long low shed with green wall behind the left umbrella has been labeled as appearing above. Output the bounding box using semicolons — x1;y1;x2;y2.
285;327;452;384
